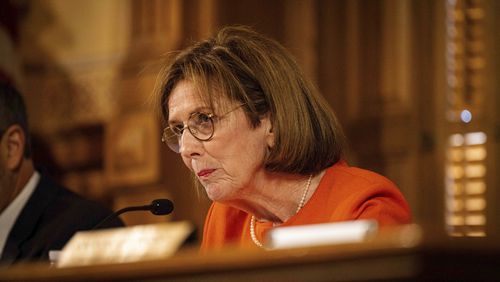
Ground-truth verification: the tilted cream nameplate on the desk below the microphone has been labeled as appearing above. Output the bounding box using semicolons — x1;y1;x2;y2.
56;221;193;267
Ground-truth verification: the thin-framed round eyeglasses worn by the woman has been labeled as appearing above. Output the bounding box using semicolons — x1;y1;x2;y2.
161;104;245;153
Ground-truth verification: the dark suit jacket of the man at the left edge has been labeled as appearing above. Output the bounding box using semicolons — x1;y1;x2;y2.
0;175;123;265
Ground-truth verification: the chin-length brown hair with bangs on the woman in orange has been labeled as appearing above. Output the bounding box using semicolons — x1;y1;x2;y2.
160;26;344;174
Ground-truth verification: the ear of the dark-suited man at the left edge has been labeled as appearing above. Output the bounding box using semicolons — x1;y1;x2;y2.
1;124;26;171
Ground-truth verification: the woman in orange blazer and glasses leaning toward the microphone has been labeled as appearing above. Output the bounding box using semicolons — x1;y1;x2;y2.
161;27;411;250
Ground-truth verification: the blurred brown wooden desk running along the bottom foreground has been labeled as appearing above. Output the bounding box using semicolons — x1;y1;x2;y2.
0;226;500;281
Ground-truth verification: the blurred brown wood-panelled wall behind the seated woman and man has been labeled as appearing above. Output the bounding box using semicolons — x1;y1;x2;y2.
0;0;500;242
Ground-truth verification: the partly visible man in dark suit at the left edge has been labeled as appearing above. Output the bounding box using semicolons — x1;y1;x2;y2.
0;82;123;265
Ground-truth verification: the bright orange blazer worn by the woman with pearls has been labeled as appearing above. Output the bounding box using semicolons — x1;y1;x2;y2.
201;161;411;251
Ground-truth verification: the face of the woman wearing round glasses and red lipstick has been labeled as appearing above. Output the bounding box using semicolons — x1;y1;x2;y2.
168;80;274;202
